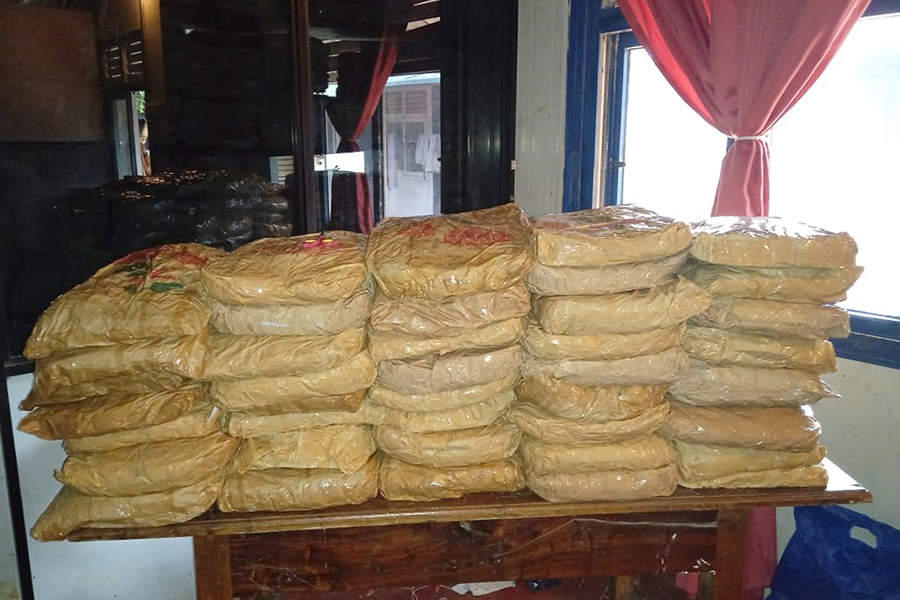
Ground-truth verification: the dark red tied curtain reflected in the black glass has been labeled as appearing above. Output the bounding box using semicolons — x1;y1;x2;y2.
328;13;408;233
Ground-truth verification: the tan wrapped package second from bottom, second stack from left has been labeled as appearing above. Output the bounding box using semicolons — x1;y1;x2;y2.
231;425;375;474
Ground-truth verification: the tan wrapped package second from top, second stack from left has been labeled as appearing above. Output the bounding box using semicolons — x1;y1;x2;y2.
210;287;372;335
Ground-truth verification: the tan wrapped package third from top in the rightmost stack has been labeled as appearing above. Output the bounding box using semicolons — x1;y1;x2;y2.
692;298;850;340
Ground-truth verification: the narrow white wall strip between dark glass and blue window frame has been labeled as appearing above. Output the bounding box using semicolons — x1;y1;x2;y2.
515;0;569;215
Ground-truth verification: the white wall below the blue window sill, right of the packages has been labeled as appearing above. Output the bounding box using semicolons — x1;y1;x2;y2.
778;359;900;552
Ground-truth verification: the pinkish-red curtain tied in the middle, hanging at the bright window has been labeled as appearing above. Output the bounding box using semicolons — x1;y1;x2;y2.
619;0;869;216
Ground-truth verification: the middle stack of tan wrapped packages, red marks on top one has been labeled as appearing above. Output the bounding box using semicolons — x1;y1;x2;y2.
366;204;531;500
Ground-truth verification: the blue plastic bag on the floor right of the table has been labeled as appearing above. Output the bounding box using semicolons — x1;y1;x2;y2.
768;506;900;600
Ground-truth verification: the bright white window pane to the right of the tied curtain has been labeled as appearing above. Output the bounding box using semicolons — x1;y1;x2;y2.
770;15;900;316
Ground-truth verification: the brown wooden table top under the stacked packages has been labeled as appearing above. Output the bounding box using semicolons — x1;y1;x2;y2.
68;459;872;541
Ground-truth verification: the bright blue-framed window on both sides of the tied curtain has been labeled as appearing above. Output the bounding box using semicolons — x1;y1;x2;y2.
567;0;900;368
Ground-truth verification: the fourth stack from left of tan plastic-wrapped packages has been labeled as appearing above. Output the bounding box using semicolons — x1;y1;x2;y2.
509;206;710;502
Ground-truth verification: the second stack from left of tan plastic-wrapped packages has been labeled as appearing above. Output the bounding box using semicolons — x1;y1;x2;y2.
203;232;377;512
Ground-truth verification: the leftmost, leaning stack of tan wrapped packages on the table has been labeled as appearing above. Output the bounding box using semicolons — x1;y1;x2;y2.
19;244;236;540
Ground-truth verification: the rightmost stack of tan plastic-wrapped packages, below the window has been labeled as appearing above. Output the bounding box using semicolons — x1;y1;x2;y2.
662;217;862;488
